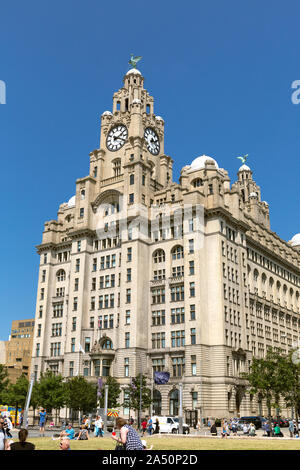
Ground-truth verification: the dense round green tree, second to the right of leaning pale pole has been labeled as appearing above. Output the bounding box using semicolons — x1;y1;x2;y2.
66;376;97;422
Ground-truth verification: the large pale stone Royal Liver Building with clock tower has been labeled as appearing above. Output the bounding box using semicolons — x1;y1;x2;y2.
32;68;300;417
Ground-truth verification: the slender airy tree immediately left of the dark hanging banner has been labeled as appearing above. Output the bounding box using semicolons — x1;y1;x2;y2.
123;374;153;425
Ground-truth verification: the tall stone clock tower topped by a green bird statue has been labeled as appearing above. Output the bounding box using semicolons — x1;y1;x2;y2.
90;68;173;205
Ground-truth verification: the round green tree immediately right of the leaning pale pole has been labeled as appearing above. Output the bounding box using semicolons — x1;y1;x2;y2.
31;370;67;421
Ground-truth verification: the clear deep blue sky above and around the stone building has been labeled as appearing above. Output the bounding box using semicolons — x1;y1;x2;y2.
0;0;300;340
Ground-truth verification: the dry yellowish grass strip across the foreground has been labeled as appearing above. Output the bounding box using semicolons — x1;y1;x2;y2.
28;436;300;450
